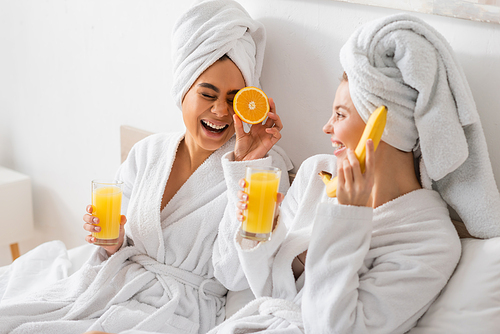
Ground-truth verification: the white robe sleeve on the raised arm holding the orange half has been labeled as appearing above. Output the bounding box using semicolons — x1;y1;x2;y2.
212;150;290;291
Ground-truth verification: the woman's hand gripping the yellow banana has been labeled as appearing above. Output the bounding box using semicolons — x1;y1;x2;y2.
337;139;375;206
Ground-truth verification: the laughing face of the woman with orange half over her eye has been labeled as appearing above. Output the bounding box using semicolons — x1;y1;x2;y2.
182;58;245;152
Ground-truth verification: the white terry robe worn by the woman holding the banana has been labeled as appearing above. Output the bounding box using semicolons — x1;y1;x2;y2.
209;155;461;334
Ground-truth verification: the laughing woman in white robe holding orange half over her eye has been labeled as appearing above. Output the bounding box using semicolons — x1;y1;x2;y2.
0;0;291;333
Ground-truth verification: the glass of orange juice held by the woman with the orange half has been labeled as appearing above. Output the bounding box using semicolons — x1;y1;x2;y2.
92;180;123;246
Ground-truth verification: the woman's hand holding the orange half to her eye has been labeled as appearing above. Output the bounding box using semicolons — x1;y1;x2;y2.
233;98;283;161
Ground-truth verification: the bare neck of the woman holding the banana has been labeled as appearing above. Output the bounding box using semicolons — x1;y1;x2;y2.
368;141;421;208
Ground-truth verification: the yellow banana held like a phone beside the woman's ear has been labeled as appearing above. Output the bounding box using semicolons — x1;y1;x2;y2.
319;106;387;197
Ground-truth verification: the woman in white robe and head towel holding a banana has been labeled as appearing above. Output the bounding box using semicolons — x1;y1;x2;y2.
210;11;499;334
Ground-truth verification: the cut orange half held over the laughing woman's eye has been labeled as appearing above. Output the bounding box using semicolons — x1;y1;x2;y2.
233;86;269;124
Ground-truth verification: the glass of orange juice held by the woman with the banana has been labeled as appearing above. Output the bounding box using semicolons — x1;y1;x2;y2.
240;167;281;241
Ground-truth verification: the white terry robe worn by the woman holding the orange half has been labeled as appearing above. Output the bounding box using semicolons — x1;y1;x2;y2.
0;133;288;334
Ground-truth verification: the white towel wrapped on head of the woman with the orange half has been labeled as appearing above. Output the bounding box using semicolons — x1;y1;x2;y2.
172;0;266;109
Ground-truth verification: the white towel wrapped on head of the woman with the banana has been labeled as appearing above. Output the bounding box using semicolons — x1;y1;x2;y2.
340;14;500;238
